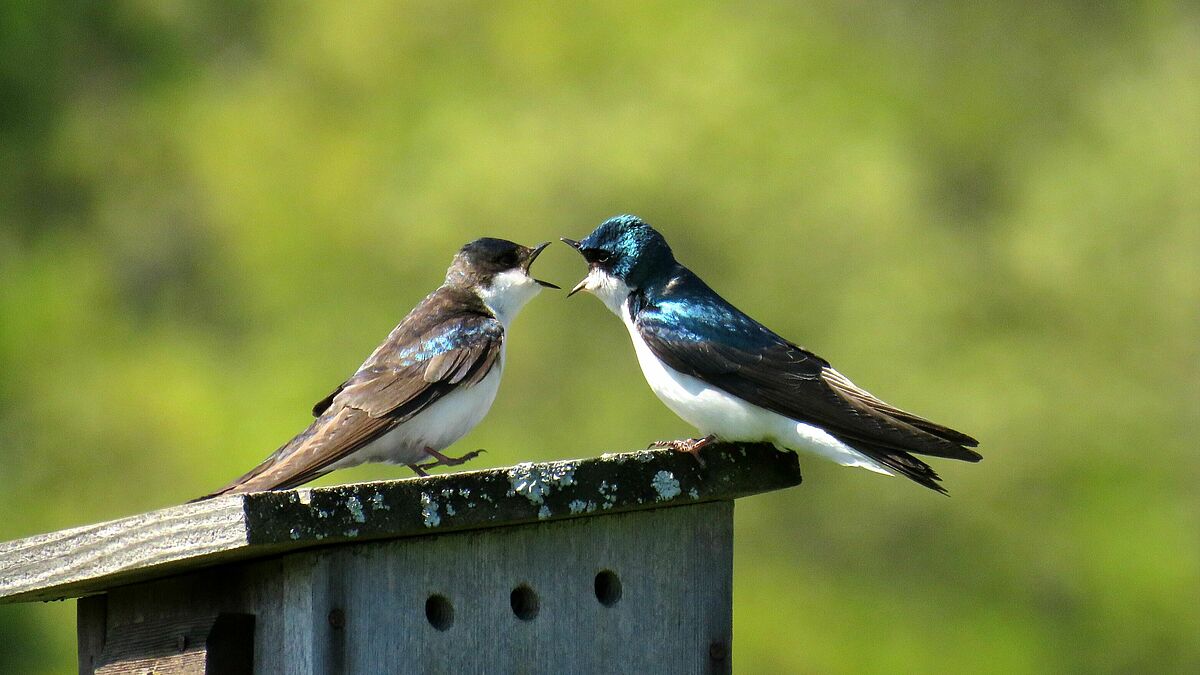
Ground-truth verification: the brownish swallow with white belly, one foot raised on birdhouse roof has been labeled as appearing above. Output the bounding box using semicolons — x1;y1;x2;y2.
200;238;558;498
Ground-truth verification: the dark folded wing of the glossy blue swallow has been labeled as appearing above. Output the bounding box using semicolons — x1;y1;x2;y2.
636;307;979;461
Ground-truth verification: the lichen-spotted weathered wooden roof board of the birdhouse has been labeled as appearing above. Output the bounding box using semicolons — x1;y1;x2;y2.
7;444;800;602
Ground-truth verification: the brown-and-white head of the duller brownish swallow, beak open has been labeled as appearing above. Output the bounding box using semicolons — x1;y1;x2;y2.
445;237;558;323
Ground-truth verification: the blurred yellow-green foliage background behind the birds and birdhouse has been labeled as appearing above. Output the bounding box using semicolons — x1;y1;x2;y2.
0;0;1200;673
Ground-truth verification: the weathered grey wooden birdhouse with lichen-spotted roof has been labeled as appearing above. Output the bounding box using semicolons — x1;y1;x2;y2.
7;446;800;674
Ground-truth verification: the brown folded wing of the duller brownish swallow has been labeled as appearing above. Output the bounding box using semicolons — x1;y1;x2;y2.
195;302;504;498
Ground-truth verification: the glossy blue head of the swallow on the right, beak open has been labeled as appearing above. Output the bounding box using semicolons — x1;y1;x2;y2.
563;215;674;313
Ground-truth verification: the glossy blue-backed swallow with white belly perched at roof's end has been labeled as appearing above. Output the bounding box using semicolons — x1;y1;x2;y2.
563;215;982;494
